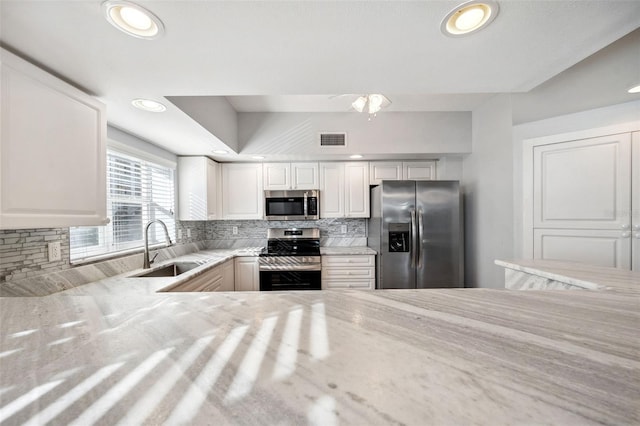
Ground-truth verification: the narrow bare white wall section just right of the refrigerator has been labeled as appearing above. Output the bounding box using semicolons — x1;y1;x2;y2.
462;95;513;288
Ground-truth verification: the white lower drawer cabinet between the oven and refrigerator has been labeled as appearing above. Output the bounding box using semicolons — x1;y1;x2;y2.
322;255;376;290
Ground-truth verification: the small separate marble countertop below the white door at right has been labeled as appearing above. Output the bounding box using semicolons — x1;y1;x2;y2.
495;259;640;292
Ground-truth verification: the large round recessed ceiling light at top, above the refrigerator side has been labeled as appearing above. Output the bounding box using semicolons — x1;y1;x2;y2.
440;0;500;37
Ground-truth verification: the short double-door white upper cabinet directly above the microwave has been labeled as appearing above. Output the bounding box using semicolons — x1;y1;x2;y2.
263;163;319;190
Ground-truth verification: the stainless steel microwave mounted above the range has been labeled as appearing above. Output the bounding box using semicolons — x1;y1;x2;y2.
264;189;320;220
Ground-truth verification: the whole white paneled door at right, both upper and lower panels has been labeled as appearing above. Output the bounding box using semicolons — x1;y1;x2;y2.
533;132;640;269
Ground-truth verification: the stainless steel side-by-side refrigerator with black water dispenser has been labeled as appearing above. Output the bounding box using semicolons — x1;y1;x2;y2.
368;181;464;289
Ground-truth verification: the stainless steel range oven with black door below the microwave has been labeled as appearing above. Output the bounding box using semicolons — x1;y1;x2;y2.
258;228;322;291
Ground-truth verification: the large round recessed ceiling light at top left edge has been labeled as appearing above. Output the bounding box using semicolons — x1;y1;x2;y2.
102;0;164;40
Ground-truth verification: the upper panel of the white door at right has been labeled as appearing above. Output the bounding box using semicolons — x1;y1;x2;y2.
533;133;631;230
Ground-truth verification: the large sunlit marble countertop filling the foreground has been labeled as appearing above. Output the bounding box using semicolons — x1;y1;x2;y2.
0;276;640;425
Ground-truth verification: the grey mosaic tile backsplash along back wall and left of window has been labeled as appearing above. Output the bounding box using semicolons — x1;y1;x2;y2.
0;219;366;282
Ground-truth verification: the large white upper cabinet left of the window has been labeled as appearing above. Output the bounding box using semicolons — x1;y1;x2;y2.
0;50;107;229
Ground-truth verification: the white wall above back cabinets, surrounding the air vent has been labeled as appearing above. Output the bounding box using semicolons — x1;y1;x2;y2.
238;111;471;159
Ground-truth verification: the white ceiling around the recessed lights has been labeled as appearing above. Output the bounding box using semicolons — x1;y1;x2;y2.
0;0;640;155
